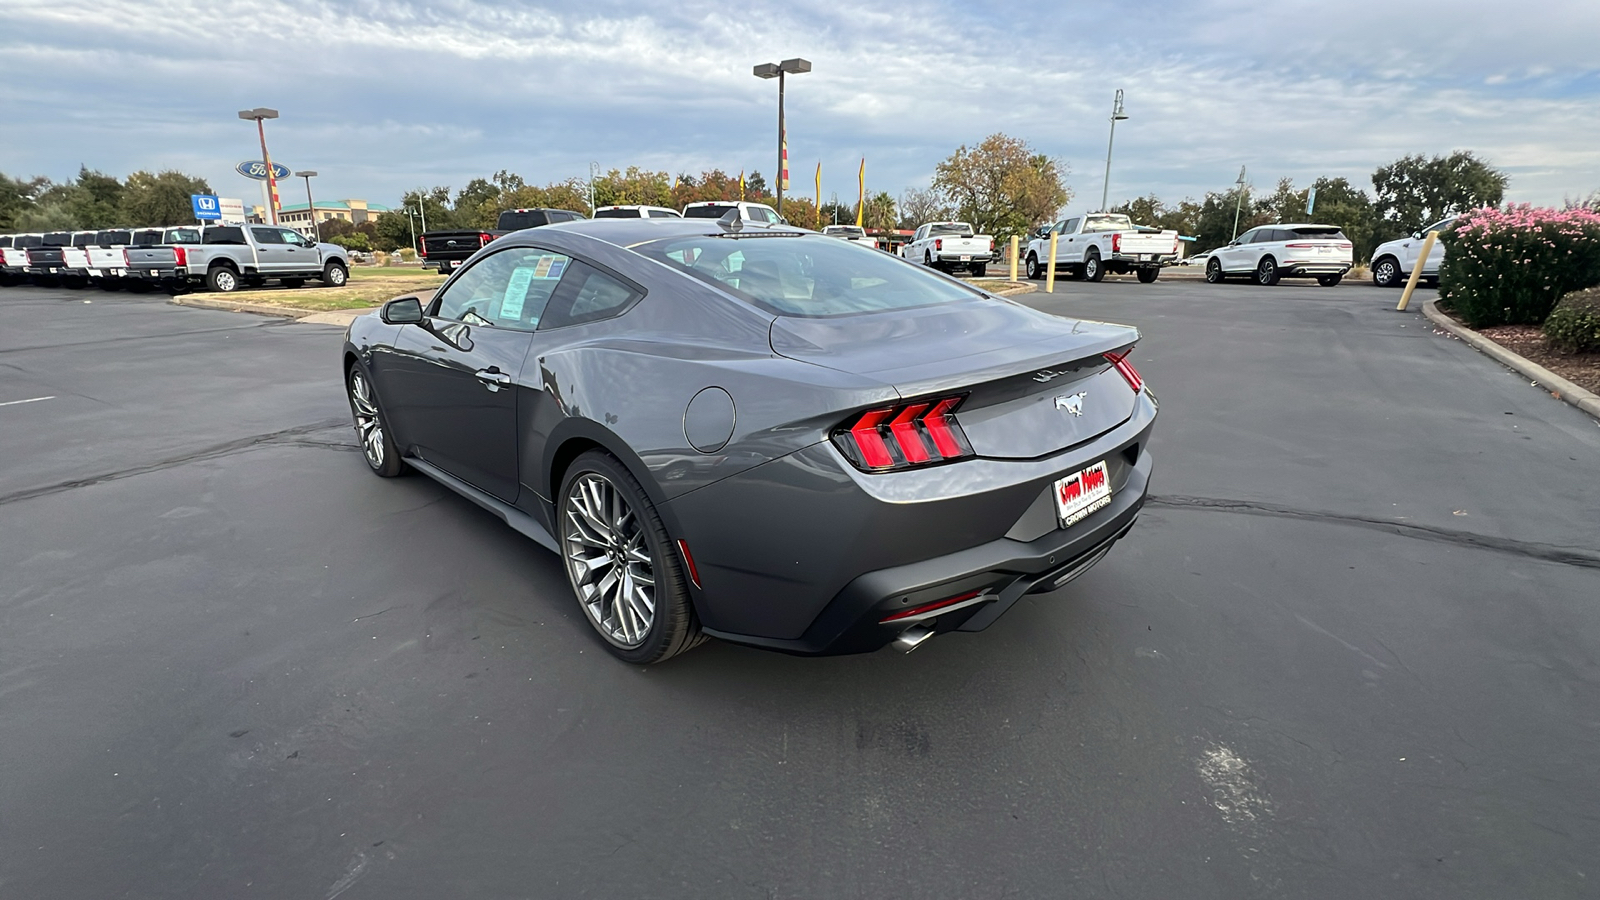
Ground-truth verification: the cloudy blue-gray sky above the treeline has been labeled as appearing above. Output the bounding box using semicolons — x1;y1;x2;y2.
0;0;1600;208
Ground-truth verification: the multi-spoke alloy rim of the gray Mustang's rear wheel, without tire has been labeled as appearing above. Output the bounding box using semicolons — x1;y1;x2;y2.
562;472;656;649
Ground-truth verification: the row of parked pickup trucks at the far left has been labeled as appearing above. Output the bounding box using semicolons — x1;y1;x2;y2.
0;224;350;293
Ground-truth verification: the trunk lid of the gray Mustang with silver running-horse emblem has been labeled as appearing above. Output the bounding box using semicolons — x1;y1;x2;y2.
771;299;1139;460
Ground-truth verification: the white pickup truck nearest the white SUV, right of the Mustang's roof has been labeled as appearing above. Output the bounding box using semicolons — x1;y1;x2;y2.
1027;213;1178;283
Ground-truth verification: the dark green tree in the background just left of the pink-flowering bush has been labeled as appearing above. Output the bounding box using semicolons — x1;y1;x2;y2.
1373;151;1509;239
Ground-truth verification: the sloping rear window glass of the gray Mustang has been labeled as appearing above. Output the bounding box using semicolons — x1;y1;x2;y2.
634;234;982;317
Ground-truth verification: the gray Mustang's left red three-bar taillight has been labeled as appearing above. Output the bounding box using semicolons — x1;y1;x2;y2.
834;397;973;472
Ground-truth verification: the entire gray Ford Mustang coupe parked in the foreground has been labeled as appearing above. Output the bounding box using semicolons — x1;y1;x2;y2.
344;216;1157;663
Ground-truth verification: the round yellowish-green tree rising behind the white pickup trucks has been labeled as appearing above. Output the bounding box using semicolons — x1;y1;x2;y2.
933;133;1072;240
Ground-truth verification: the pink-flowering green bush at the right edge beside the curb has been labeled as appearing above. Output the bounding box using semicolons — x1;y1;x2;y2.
1438;205;1600;328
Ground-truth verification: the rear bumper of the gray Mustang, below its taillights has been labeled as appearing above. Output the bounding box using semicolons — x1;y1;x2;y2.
672;394;1155;655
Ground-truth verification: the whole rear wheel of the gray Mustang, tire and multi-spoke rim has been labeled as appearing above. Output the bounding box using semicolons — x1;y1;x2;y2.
557;450;704;665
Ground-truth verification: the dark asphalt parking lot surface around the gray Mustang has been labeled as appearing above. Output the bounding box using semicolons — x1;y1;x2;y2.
0;277;1600;900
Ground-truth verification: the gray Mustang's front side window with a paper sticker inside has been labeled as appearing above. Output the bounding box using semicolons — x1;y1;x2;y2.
435;247;571;331
